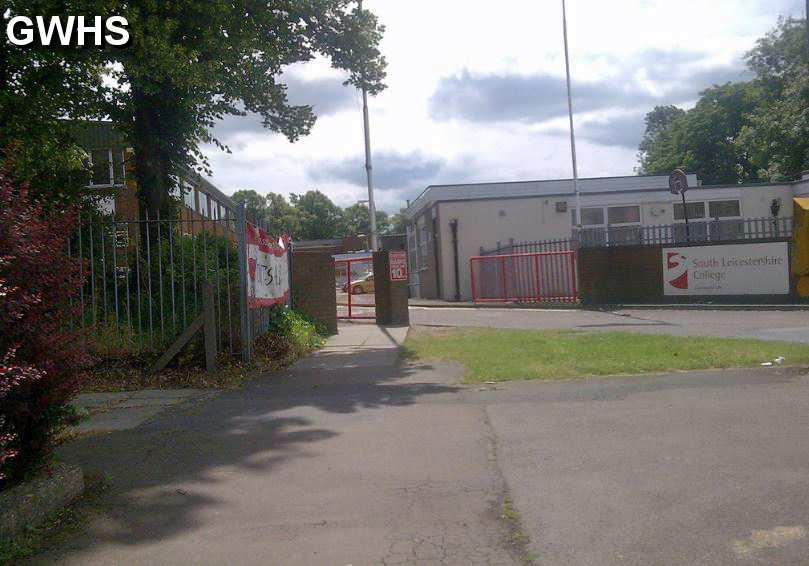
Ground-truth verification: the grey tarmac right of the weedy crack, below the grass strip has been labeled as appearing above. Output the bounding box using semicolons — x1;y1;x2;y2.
482;369;809;566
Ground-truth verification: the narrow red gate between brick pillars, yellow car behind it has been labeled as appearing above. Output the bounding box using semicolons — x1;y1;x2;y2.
334;255;376;319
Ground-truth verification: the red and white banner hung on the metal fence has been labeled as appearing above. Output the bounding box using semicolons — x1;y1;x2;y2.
246;223;289;309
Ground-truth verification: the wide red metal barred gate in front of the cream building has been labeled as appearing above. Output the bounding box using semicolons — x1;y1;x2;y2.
469;251;579;303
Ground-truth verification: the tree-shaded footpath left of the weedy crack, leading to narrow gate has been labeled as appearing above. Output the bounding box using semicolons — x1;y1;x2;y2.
37;324;516;566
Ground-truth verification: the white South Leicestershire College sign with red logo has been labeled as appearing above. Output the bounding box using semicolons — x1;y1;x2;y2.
663;242;789;296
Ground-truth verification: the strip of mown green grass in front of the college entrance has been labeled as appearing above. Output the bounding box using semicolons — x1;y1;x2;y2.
403;329;809;383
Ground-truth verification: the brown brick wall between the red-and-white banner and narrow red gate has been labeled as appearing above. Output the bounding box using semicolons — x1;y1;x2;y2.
292;252;337;334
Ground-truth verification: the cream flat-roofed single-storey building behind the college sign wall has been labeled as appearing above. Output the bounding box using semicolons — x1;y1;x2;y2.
404;174;809;301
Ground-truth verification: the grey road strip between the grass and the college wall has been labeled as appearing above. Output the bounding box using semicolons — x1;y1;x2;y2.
410;307;809;343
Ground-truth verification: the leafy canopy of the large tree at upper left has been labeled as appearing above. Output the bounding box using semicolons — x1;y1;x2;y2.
0;0;385;217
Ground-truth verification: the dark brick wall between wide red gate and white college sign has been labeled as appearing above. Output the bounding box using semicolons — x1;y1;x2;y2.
578;246;663;304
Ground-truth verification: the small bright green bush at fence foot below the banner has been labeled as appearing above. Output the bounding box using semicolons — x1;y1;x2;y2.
254;306;323;367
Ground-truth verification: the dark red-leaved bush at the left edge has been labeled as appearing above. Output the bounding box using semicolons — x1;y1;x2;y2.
0;171;89;489
